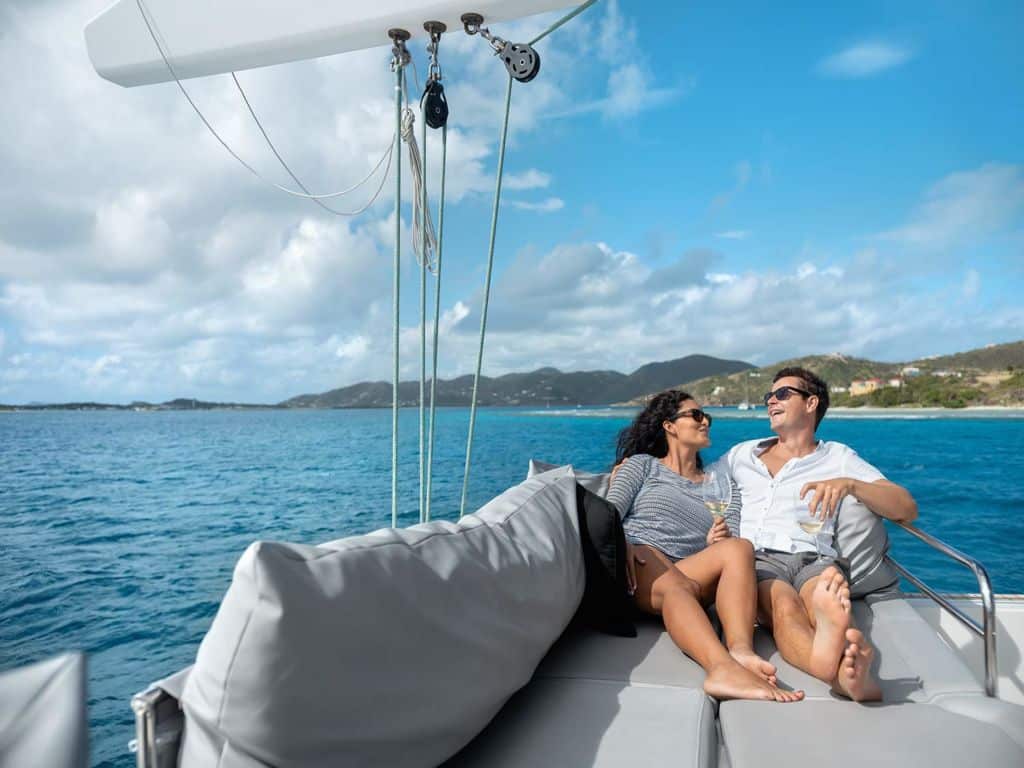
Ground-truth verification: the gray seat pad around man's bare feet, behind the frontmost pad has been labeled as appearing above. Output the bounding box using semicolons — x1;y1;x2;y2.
754;598;984;702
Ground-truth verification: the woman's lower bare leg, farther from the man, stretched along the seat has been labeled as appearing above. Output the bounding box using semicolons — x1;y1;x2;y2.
635;545;804;701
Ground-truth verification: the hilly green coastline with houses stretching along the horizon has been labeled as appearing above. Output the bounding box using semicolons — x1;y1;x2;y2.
0;341;1024;411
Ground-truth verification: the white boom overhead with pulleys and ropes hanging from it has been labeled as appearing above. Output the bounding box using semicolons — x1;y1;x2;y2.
85;0;573;86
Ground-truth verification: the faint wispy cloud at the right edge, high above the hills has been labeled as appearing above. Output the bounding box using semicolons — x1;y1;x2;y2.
879;163;1024;251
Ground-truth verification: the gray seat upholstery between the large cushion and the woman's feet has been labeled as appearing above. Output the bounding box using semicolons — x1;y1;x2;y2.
446;621;718;768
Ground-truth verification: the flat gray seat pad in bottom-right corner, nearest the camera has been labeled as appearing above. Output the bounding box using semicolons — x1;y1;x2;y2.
719;700;1024;768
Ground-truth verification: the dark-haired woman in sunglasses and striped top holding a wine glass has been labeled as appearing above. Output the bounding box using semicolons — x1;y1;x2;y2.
608;389;804;701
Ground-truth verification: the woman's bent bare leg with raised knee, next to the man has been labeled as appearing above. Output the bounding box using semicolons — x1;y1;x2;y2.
676;539;776;684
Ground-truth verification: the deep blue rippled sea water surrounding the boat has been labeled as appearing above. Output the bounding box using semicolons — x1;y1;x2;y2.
0;409;1024;766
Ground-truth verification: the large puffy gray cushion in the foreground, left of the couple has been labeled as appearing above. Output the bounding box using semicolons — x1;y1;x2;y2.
181;476;584;768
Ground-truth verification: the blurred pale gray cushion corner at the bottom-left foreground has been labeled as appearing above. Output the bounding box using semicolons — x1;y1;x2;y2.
0;653;89;768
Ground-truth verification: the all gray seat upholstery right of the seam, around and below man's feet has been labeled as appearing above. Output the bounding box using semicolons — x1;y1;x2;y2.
719;598;1024;768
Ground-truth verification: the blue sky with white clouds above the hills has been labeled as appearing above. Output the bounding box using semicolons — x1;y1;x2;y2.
0;0;1024;403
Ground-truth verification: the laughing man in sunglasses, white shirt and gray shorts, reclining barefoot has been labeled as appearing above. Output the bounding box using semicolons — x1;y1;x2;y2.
725;368;918;701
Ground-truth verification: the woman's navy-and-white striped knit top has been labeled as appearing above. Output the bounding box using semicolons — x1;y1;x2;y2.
608;454;741;560
